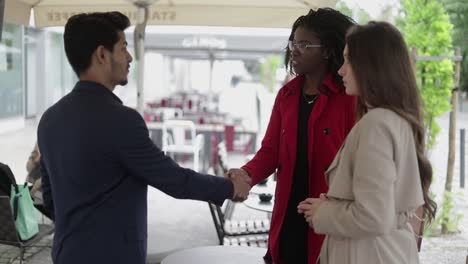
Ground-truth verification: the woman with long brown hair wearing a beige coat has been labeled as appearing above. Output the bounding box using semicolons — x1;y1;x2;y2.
298;22;436;264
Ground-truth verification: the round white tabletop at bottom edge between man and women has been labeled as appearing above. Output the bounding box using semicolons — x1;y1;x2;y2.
161;246;266;264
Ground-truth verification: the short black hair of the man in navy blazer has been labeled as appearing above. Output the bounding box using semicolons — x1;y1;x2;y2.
63;12;130;77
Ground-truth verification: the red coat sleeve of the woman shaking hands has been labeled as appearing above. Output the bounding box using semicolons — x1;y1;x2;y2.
242;90;282;185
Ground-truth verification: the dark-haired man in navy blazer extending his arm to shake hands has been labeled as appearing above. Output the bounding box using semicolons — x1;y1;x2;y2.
38;12;250;264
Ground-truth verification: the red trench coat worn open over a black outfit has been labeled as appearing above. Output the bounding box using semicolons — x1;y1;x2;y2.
242;74;356;264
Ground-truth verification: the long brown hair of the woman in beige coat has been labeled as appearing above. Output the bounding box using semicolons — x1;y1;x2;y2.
346;22;437;223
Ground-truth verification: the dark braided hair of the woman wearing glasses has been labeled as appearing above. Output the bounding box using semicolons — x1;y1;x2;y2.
284;8;355;89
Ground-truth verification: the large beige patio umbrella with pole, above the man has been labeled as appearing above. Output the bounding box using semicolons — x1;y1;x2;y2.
5;0;338;111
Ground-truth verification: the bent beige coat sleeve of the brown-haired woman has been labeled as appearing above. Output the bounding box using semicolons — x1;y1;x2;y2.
312;118;396;238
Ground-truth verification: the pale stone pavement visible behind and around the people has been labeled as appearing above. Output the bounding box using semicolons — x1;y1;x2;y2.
0;104;468;264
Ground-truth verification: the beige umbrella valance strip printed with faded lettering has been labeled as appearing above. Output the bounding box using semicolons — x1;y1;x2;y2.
35;5;310;28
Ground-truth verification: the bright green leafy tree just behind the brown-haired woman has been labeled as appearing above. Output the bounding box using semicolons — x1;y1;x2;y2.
397;0;453;148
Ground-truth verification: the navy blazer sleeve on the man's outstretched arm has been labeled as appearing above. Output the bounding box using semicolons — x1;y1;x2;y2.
117;110;233;205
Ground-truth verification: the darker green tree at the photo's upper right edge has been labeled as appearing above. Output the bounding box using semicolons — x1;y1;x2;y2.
444;0;468;92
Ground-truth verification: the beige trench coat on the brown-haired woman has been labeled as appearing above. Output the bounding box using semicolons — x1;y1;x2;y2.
312;108;424;264
